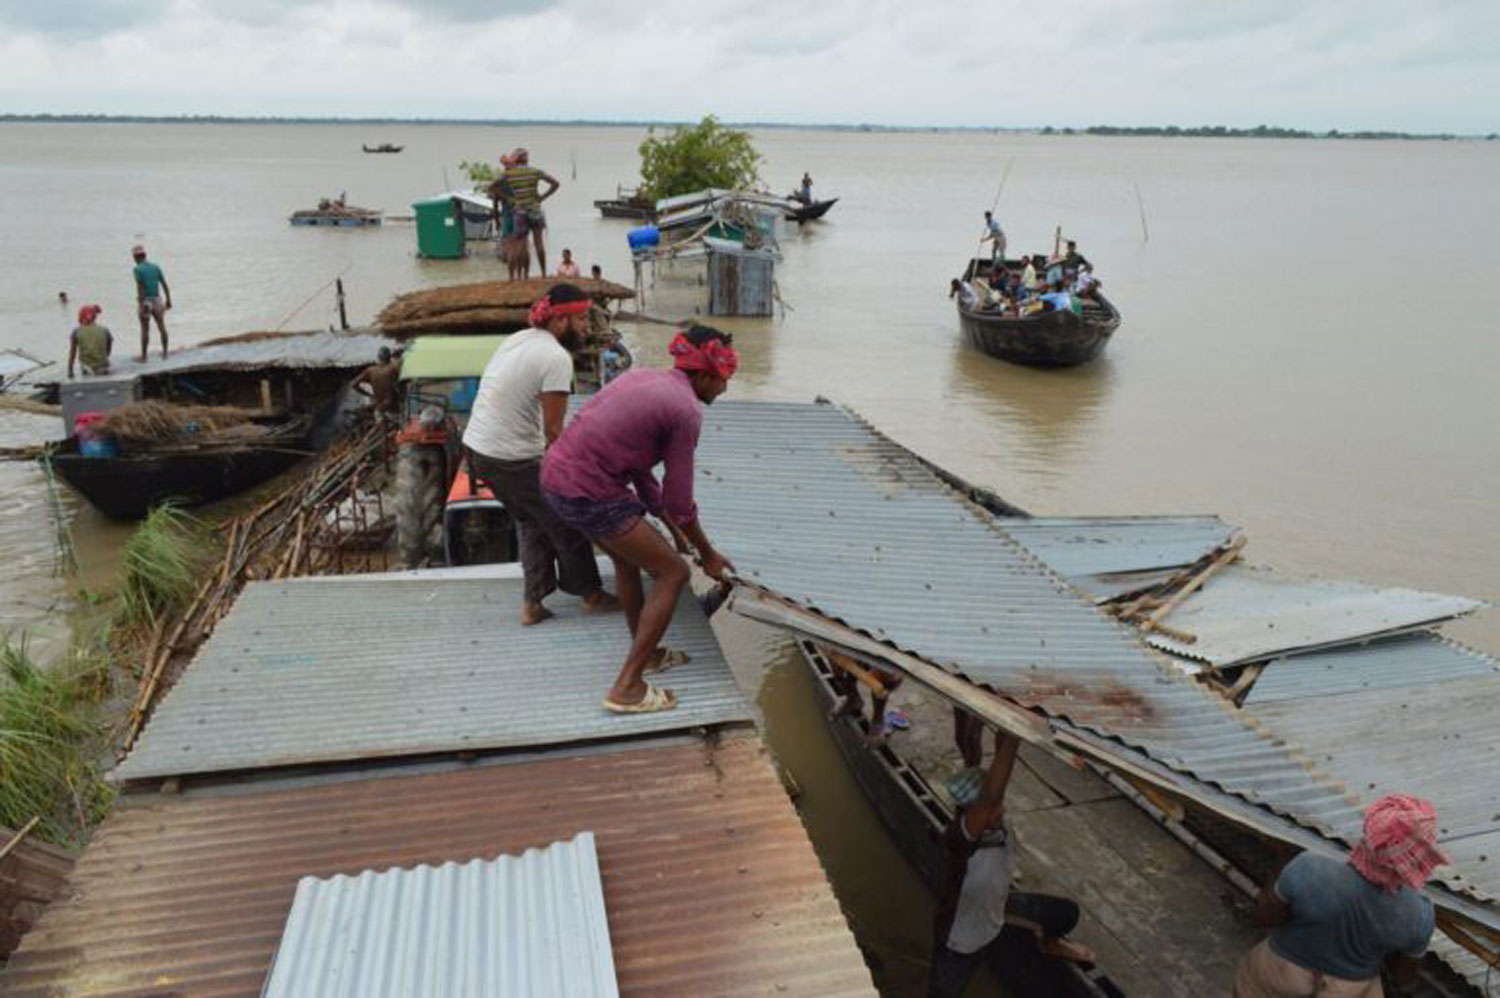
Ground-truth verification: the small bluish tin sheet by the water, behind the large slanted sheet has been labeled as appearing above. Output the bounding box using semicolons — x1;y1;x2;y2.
1004;516;1235;599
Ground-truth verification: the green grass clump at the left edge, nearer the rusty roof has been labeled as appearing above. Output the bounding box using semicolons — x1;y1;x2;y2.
0;635;113;845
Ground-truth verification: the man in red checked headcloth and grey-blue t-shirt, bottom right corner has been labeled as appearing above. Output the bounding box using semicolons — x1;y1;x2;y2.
1235;794;1448;998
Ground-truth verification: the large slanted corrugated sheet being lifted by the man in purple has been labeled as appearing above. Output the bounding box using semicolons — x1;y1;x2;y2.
698;404;1359;834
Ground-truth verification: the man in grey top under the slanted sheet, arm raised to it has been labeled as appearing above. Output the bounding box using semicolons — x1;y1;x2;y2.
927;731;1094;998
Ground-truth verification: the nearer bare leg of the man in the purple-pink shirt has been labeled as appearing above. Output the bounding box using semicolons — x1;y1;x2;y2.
600;521;689;704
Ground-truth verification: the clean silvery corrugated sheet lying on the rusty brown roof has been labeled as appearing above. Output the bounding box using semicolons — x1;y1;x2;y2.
263;831;620;998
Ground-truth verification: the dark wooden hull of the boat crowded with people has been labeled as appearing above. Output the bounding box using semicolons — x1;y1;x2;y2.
957;260;1121;368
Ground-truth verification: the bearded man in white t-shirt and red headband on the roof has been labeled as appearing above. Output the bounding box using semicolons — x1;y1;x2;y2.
464;284;620;624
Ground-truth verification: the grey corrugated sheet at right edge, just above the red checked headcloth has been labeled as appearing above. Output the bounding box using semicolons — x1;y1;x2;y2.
1245;666;1500;900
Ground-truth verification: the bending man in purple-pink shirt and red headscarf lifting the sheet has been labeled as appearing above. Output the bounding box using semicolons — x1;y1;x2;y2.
542;326;738;714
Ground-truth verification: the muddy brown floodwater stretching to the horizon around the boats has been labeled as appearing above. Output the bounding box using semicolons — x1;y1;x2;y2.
0;125;1500;992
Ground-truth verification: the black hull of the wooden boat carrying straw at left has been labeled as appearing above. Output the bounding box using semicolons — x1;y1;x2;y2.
50;438;311;519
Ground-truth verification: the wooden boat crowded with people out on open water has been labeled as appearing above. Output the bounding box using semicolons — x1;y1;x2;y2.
948;242;1121;368
